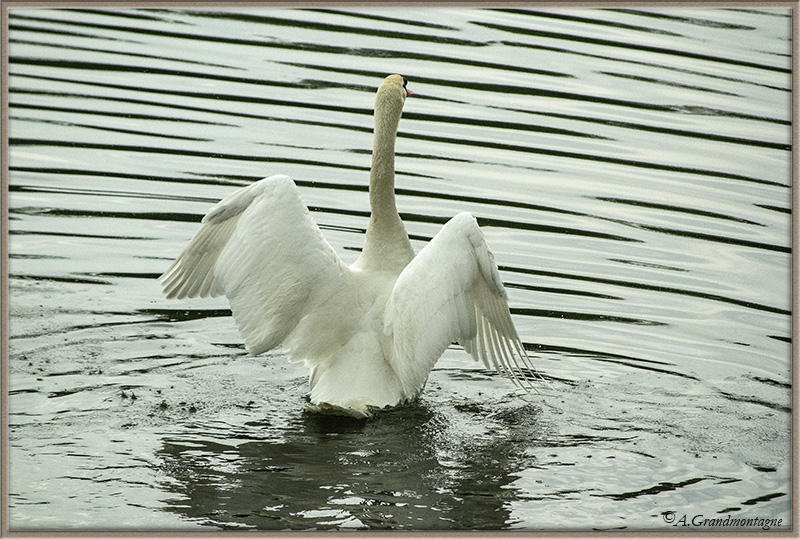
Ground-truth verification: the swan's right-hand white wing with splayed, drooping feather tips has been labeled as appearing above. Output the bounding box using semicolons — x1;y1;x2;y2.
385;213;534;392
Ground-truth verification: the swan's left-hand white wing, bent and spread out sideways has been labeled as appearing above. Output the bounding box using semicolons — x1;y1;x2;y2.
160;176;348;354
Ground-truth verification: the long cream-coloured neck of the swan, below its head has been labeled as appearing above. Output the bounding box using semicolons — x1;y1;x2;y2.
357;92;414;273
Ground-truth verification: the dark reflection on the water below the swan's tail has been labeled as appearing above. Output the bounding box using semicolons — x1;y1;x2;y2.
159;404;538;529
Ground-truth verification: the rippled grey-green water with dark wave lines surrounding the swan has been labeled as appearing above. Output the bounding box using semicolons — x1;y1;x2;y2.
8;8;792;531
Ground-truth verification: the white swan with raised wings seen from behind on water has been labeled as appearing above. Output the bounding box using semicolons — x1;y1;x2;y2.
159;75;535;417
